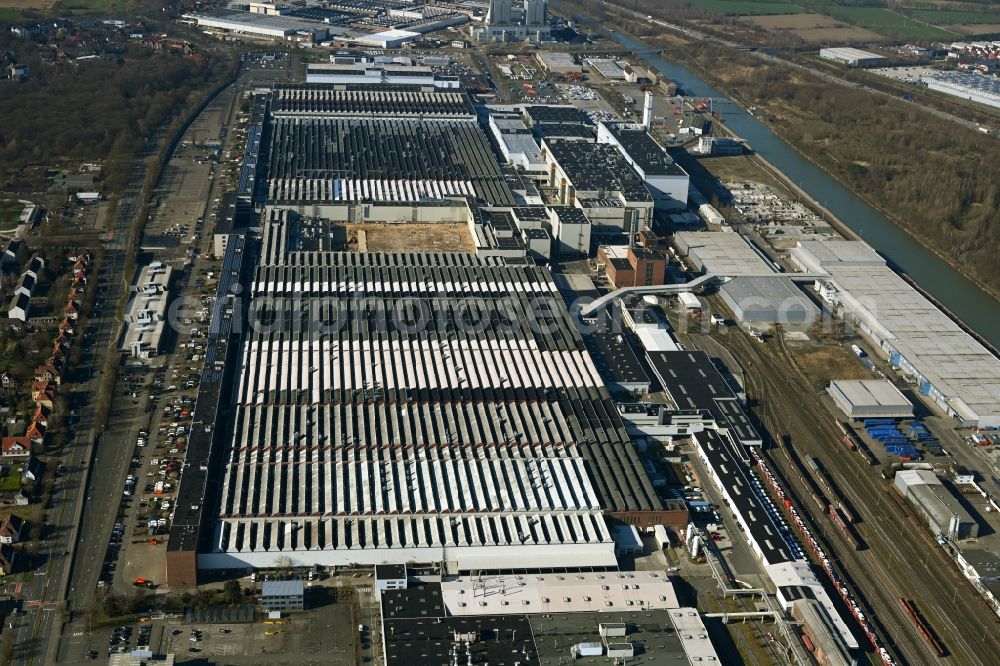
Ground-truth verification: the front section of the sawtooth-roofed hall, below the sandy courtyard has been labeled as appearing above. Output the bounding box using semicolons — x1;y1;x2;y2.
198;216;678;570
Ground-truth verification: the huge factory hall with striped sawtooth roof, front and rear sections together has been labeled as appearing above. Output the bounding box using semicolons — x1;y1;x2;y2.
168;84;687;580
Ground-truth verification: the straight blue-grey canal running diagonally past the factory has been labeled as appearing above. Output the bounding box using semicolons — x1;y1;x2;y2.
579;17;1000;347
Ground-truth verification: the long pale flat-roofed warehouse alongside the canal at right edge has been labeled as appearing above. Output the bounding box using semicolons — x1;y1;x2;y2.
790;240;1000;427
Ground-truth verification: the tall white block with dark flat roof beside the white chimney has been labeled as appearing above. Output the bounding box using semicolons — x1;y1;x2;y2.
597;122;691;210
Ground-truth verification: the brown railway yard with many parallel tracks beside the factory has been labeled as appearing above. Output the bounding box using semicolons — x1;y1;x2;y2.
700;330;1000;666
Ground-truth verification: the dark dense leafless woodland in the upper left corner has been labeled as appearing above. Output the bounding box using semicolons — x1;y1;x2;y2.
0;33;229;191
